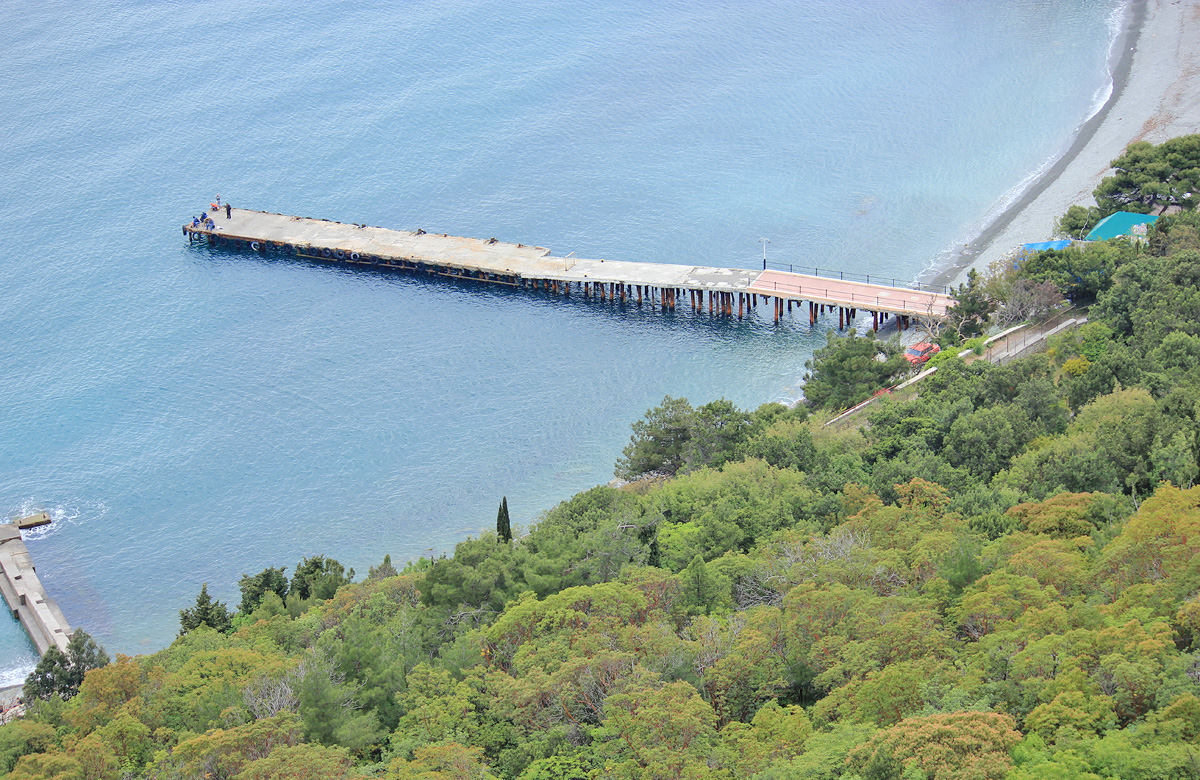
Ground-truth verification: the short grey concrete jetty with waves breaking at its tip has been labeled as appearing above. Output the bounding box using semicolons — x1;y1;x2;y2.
0;512;71;655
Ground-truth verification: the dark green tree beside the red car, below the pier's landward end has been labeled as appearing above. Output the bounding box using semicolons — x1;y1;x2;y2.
804;331;908;410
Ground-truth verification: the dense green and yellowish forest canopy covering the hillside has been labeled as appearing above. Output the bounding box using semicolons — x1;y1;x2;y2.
7;142;1200;780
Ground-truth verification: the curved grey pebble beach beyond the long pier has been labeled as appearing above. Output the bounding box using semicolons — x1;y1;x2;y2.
922;0;1200;284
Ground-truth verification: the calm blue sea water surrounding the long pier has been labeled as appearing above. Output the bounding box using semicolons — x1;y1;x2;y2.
0;0;1118;682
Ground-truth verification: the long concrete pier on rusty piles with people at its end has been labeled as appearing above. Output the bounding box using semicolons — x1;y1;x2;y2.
184;209;952;330
